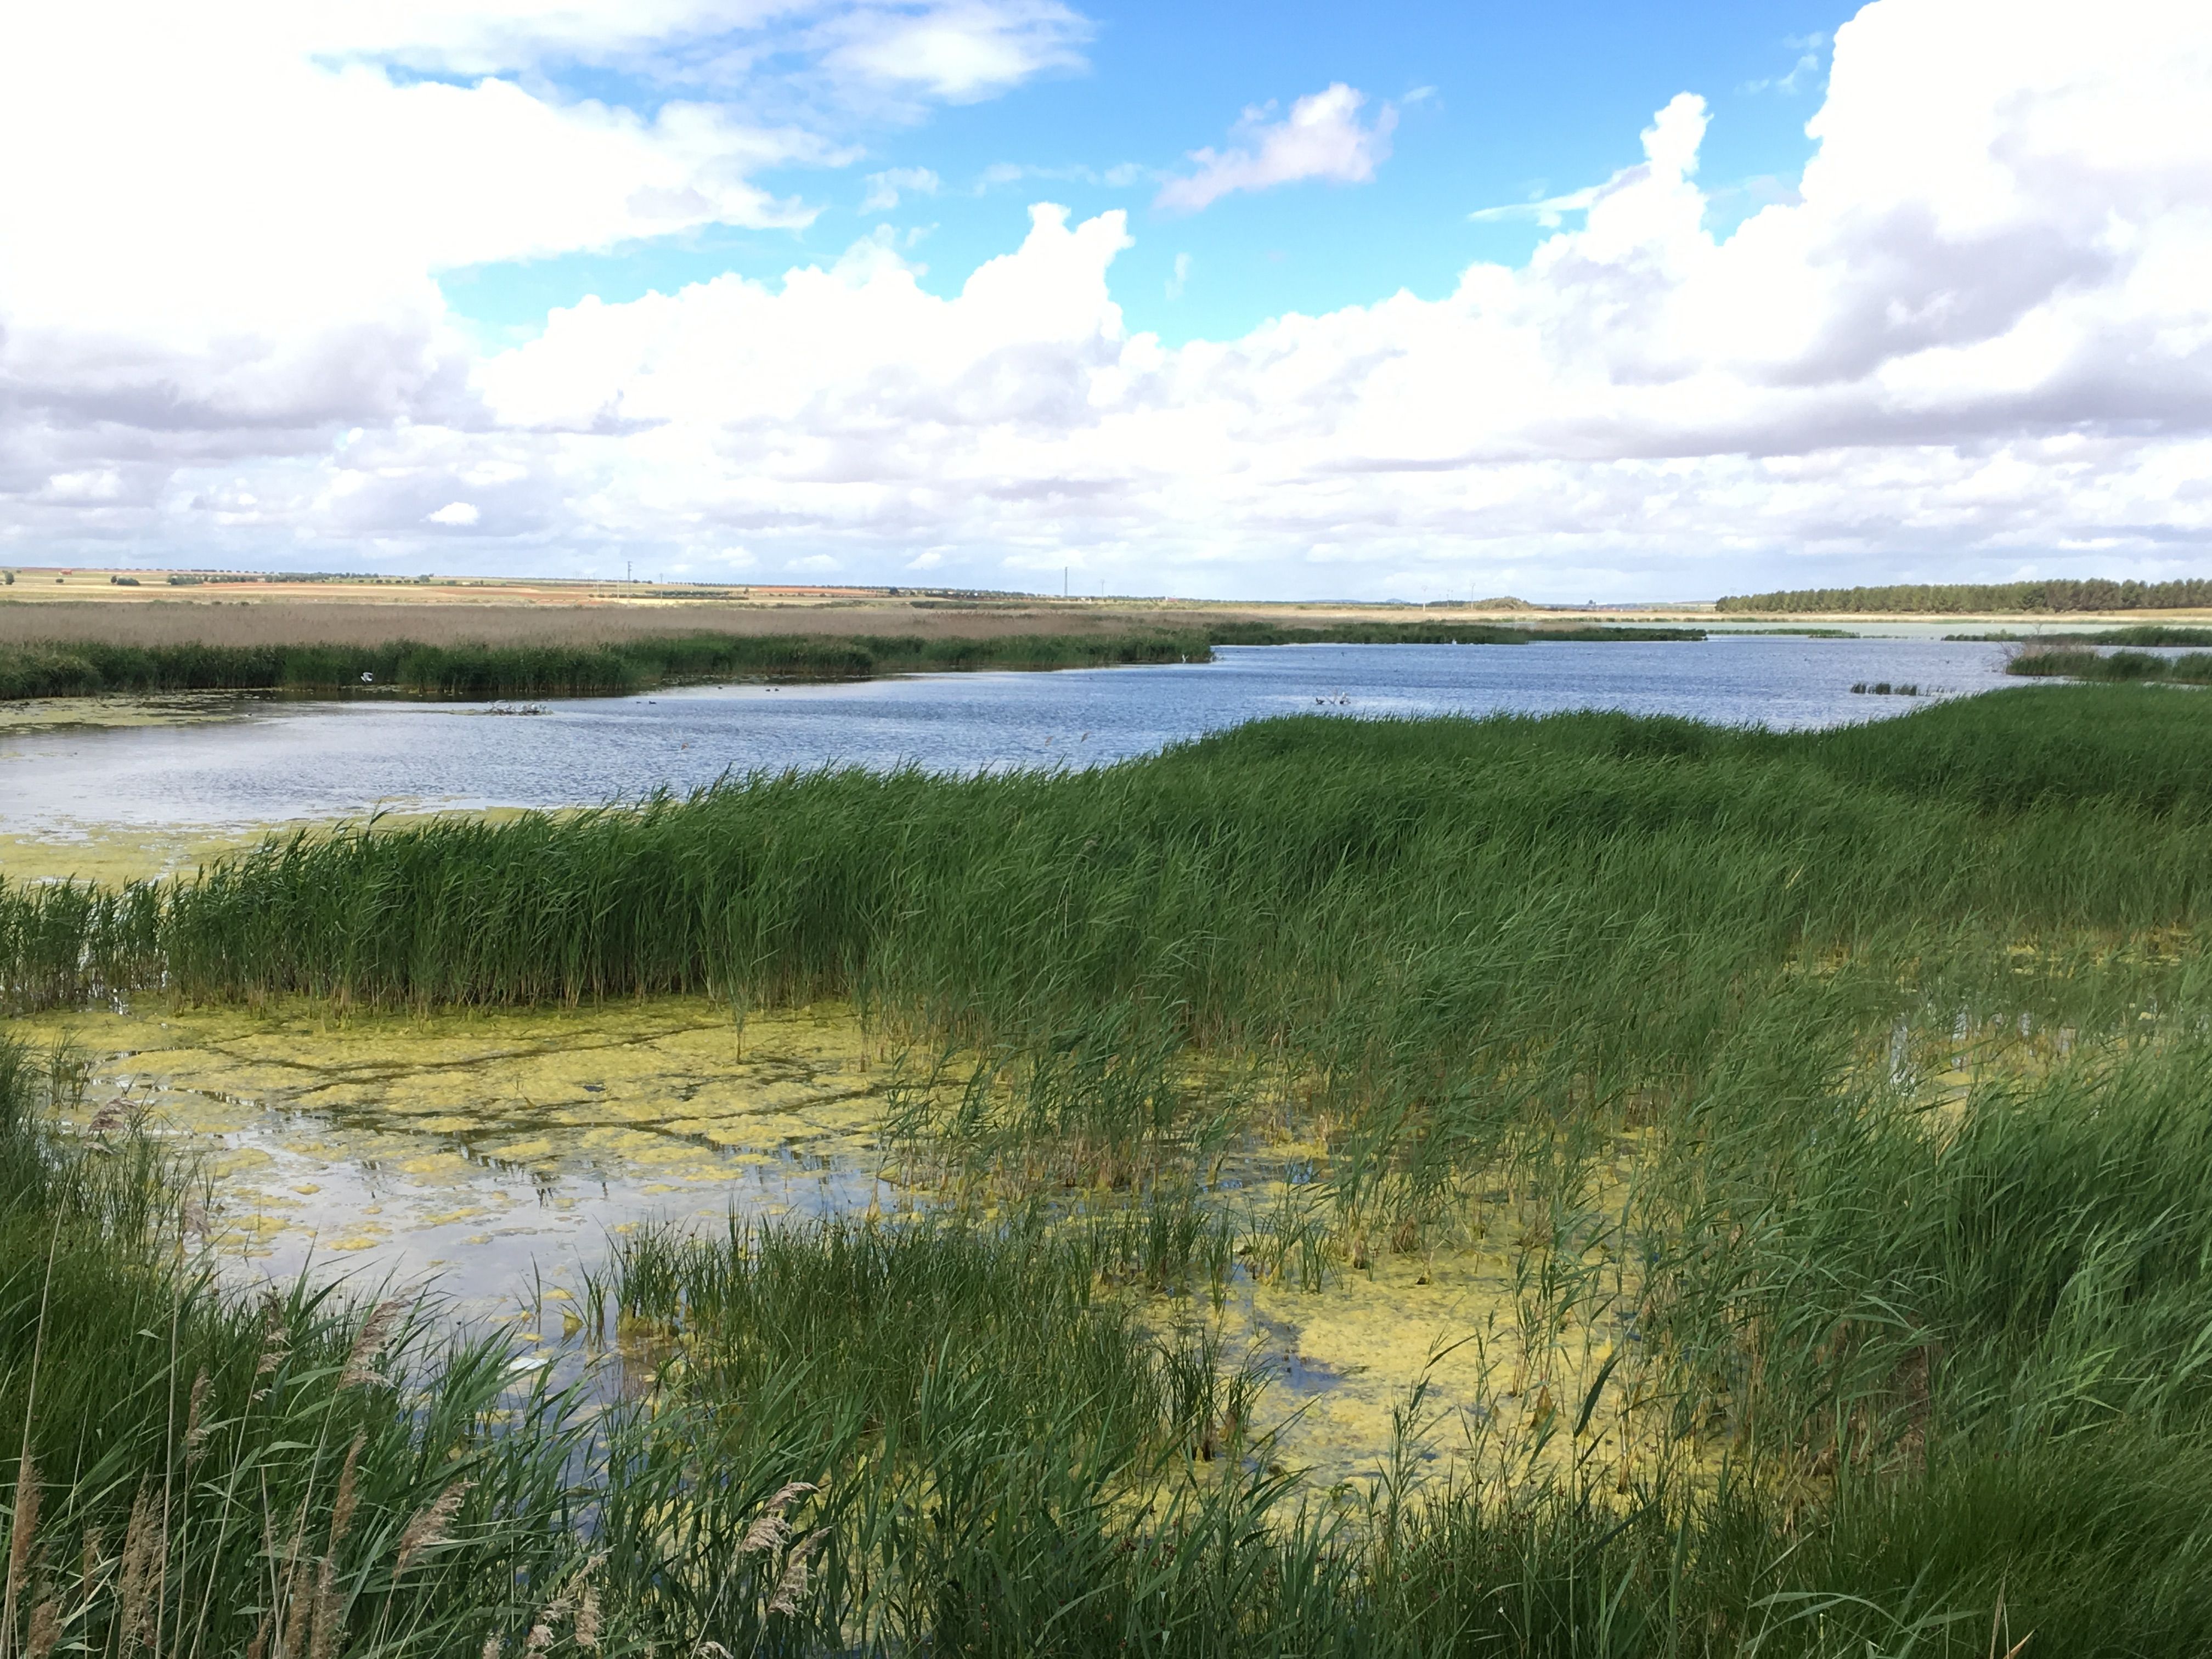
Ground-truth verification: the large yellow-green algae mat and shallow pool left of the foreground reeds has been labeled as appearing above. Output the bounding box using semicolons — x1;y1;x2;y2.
13;1000;881;1301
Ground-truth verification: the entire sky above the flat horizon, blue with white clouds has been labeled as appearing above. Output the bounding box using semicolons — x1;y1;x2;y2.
0;0;2212;602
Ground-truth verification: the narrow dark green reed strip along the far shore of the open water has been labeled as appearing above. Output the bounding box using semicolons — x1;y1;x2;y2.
0;622;1703;699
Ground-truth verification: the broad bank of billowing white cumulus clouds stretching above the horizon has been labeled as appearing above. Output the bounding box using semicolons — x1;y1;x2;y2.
0;0;2212;595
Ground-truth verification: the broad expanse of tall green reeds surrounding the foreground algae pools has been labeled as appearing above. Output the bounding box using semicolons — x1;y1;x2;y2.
0;686;2212;1659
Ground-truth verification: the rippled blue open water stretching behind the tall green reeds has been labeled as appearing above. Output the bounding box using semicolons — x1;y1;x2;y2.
0;635;2017;836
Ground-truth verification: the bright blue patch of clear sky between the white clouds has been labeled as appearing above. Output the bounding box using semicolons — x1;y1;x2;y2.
440;0;1849;345
